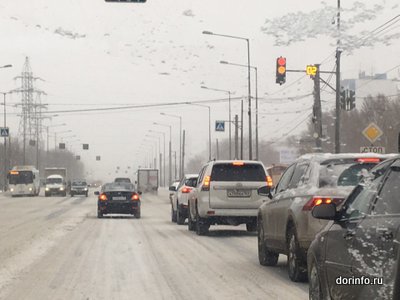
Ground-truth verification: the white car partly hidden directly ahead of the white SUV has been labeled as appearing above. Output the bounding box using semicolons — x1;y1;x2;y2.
171;174;199;225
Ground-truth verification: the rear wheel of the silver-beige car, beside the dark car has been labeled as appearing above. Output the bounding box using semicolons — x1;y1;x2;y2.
287;227;307;282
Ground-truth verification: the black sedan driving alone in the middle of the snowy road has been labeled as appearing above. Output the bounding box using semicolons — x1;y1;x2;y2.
94;182;141;218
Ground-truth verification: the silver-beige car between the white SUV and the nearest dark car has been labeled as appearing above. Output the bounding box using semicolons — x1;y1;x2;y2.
257;153;394;281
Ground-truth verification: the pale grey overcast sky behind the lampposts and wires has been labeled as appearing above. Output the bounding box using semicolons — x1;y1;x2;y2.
0;0;400;180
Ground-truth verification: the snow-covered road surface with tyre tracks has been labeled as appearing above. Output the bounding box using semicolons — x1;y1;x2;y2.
0;191;308;300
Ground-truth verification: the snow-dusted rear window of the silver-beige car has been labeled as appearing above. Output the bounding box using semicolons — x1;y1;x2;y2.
319;160;376;187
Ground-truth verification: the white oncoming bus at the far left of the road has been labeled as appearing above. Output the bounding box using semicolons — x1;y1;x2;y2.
8;166;40;197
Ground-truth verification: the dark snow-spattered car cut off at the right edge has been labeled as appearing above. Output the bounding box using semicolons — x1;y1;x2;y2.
307;157;400;299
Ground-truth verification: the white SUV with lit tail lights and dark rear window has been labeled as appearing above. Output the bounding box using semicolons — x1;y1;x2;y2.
188;160;272;235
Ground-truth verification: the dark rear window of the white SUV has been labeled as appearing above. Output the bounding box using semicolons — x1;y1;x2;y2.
211;163;266;181
